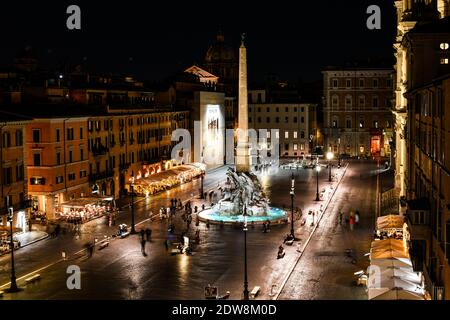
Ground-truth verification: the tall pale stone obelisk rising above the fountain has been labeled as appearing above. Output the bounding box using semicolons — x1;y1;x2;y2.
236;34;250;173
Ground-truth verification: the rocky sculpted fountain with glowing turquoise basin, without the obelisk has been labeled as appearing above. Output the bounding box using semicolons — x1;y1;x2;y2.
199;168;287;224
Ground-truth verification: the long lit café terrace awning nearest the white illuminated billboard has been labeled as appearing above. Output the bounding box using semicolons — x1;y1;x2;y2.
128;164;202;196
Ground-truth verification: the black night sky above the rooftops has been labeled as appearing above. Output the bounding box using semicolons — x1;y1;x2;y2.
0;0;396;81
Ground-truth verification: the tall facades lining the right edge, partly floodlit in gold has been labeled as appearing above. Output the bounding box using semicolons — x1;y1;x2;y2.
393;1;450;299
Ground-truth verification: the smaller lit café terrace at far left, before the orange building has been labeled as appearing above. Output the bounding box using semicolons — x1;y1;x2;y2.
56;197;115;223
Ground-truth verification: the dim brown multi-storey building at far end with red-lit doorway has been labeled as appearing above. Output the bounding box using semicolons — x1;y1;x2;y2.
322;67;393;157
